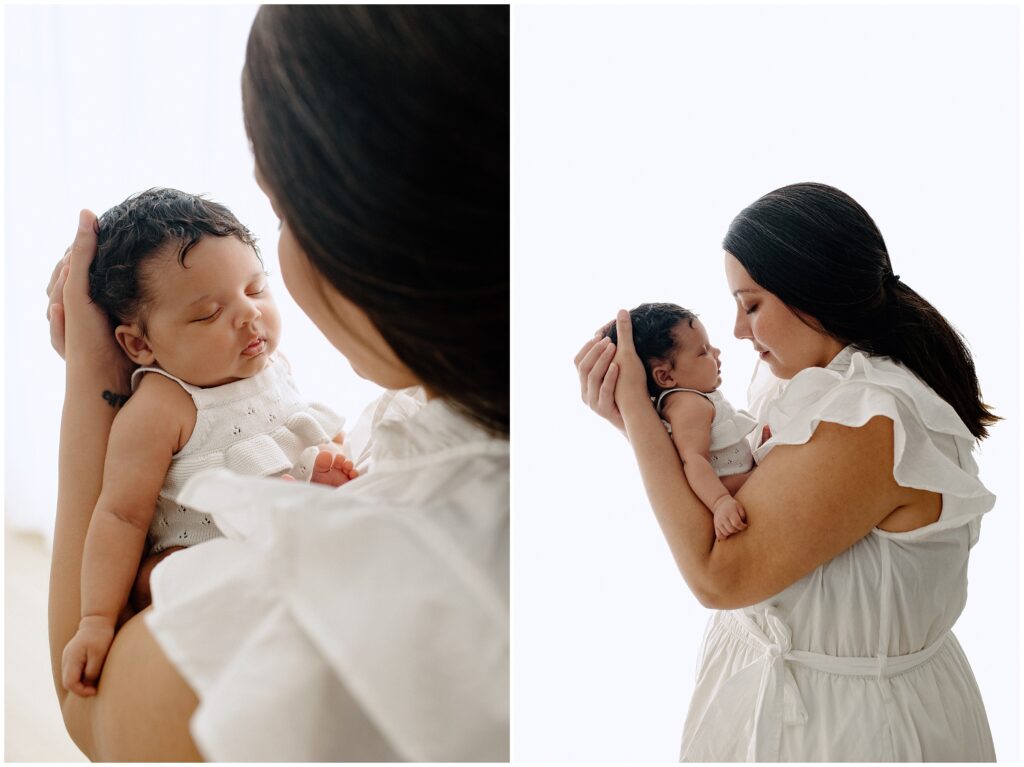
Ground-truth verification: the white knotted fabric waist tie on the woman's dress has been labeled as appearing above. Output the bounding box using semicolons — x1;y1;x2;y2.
723;608;949;762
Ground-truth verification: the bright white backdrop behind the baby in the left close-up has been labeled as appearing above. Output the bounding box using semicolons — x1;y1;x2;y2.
3;5;380;536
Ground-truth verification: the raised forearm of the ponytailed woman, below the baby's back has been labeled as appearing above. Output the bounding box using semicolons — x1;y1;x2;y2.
620;398;715;604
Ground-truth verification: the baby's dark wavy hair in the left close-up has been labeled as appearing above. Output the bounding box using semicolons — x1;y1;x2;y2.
89;187;263;334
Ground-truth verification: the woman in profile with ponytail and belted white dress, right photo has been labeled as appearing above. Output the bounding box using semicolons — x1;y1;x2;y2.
577;183;997;762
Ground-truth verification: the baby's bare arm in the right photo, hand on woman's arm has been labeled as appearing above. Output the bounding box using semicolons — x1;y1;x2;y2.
664;392;746;541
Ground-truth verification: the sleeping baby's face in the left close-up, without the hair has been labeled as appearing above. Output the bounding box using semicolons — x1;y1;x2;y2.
129;237;281;386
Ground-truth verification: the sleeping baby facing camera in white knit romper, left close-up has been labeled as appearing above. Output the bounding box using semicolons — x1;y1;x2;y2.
61;189;357;695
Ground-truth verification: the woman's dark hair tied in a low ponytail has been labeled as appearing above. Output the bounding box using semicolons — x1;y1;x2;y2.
722;183;1000;439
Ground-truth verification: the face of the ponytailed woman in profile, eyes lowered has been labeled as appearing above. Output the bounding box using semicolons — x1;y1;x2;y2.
725;252;843;379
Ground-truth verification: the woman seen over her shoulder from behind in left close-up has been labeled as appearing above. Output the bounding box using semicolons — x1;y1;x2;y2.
48;6;509;761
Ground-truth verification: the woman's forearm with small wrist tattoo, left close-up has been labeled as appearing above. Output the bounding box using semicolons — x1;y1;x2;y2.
49;364;129;700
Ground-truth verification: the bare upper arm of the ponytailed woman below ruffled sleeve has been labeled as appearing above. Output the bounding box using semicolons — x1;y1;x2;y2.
707;416;907;608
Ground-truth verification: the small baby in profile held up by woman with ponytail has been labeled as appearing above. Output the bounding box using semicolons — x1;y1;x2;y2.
604;303;756;541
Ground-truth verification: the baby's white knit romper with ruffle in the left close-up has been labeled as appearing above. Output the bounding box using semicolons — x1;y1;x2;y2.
131;354;345;554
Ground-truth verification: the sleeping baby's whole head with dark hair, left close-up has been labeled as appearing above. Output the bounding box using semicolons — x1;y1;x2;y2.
89;188;281;386
